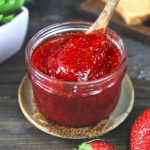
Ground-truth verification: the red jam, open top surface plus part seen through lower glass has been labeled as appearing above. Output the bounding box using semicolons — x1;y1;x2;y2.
31;31;125;127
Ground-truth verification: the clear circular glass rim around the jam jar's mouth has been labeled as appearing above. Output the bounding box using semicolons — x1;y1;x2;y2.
25;21;127;85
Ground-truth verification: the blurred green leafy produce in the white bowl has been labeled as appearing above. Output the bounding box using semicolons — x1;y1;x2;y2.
0;0;32;24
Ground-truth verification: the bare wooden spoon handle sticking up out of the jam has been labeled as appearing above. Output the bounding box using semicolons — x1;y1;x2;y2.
86;0;120;34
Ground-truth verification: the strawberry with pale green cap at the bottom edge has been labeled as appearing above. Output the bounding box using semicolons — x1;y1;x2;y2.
78;140;117;150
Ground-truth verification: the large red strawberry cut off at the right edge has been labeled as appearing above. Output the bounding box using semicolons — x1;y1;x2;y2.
130;108;150;150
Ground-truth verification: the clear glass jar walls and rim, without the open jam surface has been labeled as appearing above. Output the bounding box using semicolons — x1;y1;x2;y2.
25;22;127;127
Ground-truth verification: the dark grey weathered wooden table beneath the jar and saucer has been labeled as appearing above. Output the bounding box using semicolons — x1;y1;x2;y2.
0;0;150;150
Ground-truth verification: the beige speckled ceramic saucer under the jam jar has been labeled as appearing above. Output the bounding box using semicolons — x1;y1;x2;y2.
18;75;134;139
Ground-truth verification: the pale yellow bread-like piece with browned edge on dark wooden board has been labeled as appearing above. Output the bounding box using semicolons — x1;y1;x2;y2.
102;0;150;25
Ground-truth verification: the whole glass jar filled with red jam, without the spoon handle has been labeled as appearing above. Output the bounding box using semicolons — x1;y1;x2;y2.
26;22;127;127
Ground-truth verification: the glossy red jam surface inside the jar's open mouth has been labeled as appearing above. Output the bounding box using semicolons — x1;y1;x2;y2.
32;31;121;82
